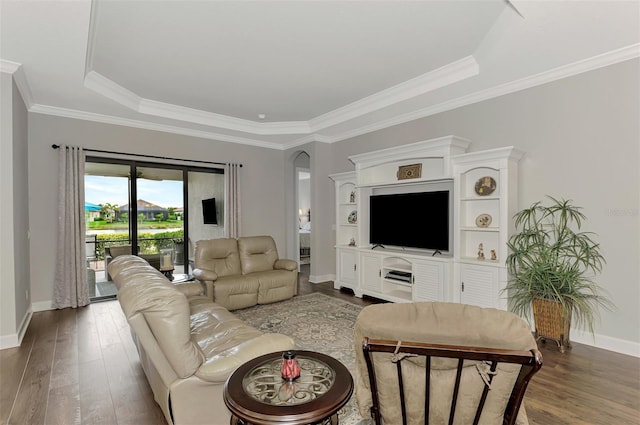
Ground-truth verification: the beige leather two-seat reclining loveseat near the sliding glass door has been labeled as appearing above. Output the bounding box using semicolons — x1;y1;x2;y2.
193;236;298;310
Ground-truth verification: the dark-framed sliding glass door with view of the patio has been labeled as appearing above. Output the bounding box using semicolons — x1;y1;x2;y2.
85;157;225;300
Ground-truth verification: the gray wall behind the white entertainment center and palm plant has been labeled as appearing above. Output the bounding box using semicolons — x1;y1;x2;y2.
324;59;640;346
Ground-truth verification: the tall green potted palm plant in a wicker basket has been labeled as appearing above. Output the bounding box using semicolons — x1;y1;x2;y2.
505;196;612;352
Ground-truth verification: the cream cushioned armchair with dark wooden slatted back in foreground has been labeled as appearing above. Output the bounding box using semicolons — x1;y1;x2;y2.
354;302;542;425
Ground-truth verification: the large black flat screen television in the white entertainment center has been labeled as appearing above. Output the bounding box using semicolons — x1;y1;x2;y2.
369;190;450;251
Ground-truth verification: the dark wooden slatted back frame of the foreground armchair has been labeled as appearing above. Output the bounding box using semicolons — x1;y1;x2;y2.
362;338;542;425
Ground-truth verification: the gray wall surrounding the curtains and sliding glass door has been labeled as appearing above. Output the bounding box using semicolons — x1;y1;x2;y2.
29;114;285;310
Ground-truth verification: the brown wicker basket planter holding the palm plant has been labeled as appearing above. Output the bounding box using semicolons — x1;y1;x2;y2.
532;298;571;353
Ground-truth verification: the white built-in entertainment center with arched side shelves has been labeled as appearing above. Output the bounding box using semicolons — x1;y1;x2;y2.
329;136;522;309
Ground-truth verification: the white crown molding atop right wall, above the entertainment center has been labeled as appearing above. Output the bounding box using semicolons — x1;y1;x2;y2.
324;43;640;143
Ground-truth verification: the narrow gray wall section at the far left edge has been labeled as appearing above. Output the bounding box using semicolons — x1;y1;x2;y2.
0;73;31;347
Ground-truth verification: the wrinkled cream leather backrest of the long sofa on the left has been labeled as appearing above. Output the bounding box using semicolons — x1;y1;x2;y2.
109;255;204;378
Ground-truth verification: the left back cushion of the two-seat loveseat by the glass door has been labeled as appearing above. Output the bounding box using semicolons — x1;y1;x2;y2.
195;238;242;276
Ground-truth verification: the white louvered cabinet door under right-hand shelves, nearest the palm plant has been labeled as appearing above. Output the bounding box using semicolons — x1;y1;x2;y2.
460;264;501;308
